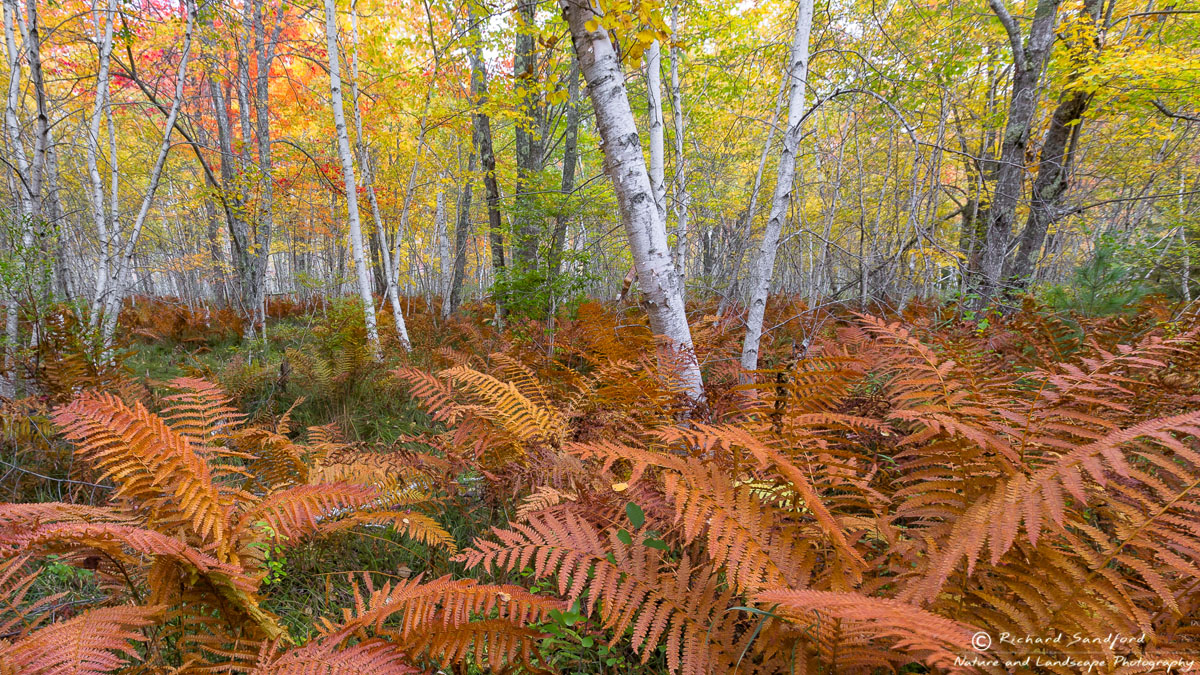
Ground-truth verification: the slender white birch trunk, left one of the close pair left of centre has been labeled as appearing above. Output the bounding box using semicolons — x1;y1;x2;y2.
325;0;383;360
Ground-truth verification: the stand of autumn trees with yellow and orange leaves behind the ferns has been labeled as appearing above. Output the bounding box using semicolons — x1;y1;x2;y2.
4;0;1198;365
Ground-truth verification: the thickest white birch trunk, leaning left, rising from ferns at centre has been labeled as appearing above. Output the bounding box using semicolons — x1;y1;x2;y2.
559;0;704;402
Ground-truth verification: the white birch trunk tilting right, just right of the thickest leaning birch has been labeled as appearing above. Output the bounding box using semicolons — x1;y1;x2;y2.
742;0;812;370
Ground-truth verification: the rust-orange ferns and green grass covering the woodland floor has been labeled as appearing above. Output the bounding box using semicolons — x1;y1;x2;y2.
0;291;1200;674
